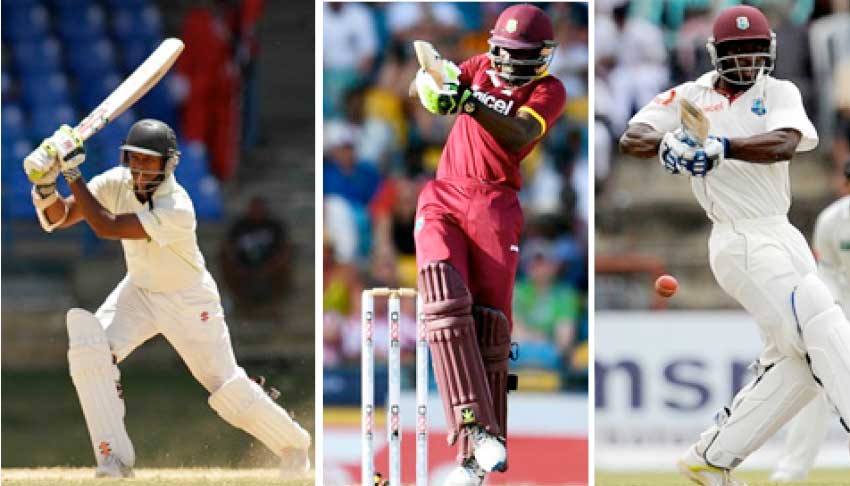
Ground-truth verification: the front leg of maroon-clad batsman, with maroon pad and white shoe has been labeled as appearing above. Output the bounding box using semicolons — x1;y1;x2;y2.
414;212;504;471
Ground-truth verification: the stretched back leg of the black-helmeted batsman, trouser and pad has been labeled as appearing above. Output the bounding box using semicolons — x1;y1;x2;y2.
155;275;310;464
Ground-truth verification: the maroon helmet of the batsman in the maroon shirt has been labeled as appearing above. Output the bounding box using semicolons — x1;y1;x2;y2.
487;4;558;86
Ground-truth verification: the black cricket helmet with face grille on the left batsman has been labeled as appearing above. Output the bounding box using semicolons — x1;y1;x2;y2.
121;118;180;193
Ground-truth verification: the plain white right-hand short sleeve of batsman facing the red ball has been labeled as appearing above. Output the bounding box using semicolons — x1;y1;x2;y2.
765;81;818;152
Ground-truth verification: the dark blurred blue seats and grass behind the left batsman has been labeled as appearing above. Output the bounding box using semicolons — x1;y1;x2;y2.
2;0;315;467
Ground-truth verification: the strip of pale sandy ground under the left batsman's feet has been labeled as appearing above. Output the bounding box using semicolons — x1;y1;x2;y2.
2;468;313;486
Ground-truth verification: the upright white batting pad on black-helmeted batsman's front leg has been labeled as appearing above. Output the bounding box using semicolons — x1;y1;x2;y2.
66;309;136;467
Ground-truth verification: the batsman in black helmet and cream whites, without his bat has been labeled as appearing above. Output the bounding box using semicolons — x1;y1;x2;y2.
24;120;310;477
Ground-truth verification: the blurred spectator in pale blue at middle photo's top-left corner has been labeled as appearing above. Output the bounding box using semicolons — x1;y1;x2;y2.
322;2;378;118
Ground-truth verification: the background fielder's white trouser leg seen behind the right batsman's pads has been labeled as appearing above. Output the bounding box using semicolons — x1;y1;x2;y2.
770;393;835;482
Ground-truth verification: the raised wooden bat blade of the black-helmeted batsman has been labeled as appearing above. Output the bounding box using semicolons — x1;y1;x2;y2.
76;37;184;140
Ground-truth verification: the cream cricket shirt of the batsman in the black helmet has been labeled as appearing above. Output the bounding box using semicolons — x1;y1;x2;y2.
88;167;206;292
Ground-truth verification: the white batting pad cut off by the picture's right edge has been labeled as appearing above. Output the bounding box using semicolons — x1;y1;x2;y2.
792;274;850;427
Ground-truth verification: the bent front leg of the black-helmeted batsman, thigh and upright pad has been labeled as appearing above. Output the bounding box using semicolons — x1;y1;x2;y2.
67;279;156;477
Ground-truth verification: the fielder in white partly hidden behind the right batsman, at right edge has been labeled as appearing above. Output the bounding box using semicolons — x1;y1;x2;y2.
770;160;850;483
